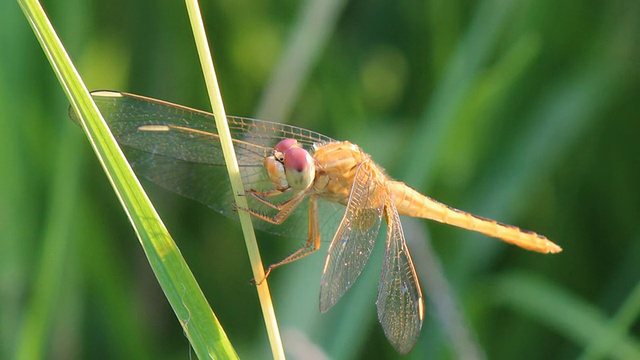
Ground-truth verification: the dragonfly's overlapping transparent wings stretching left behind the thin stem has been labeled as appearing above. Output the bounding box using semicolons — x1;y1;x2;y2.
70;91;344;238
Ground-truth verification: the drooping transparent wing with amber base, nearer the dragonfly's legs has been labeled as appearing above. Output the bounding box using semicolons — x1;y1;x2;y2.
320;162;386;312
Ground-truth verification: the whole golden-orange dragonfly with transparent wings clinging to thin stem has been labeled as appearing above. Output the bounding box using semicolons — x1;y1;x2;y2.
70;91;562;354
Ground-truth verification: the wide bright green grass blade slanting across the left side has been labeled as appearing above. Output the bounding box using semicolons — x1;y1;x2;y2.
19;0;237;358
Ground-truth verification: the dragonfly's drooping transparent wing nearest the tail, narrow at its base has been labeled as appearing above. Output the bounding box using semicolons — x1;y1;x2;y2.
376;201;424;354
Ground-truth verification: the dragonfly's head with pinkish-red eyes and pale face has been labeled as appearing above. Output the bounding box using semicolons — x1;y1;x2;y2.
265;139;316;190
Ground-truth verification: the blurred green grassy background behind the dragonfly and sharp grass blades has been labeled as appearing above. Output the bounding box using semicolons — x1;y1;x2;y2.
0;0;640;359
